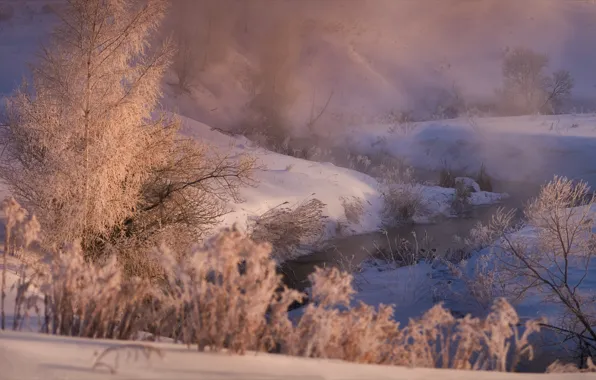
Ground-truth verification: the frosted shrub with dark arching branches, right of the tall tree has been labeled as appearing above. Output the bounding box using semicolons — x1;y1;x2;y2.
113;138;257;278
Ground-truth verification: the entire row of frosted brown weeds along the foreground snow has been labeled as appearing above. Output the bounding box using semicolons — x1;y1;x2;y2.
1;202;538;371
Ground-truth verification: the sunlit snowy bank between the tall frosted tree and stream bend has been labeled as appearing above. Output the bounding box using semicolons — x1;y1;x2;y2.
181;117;507;246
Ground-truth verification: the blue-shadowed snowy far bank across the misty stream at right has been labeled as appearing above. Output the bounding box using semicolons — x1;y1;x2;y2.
336;114;596;189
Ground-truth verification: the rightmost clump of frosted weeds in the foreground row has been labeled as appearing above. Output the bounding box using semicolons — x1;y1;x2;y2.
400;298;540;371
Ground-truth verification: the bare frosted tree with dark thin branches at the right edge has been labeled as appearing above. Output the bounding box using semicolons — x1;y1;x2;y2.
484;177;596;366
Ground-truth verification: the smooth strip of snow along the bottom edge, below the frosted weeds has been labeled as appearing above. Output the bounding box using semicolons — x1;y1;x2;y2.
0;331;593;380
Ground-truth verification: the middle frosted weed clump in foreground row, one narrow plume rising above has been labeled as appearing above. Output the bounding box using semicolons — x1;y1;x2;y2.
282;268;400;364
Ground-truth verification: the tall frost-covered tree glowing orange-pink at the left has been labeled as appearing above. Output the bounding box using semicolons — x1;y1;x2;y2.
2;0;171;252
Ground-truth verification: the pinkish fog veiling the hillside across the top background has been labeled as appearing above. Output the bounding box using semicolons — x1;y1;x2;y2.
165;0;596;134
